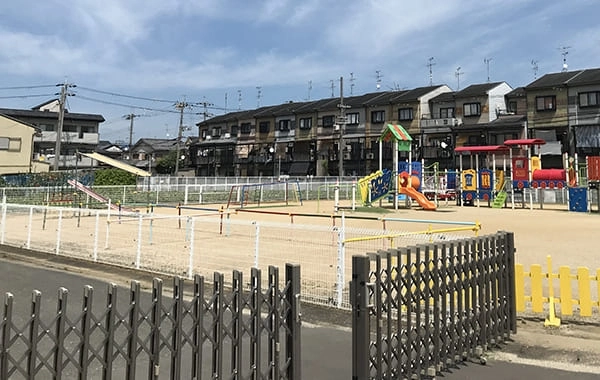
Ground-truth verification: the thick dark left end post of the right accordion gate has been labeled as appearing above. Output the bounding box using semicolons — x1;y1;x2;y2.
350;255;370;380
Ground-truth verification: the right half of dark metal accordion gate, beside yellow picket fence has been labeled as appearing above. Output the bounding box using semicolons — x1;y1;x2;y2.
350;232;516;380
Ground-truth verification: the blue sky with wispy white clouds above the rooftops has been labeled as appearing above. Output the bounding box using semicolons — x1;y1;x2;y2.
0;0;600;143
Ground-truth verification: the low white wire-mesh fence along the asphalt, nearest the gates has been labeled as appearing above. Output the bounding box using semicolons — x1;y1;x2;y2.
0;202;472;308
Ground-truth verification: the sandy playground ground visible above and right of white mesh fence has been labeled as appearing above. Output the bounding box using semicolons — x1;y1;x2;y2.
168;201;600;273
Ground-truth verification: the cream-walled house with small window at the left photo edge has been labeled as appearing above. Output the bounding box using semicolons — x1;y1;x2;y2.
0;114;50;175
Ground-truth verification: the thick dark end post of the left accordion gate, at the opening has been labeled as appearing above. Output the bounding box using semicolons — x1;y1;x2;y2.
285;264;302;380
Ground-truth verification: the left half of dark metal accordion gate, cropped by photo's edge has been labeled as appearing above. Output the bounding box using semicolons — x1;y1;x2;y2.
0;264;301;380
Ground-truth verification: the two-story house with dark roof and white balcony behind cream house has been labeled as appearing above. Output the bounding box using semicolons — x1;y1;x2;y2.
0;100;104;169
